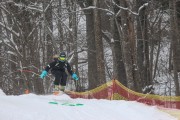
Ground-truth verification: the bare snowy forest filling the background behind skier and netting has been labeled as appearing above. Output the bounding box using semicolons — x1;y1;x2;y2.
0;0;180;96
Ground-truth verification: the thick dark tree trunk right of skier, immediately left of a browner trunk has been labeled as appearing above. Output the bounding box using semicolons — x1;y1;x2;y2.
81;0;98;89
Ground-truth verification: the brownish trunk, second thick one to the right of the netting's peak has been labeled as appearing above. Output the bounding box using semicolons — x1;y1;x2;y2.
120;0;135;90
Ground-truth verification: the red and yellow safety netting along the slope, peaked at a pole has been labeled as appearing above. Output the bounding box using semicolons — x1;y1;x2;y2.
68;80;180;109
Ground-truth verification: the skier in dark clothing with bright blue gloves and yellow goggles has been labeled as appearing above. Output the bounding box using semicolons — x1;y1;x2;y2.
40;52;79;94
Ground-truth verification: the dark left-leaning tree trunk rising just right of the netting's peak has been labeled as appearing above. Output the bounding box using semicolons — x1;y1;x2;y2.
111;0;127;86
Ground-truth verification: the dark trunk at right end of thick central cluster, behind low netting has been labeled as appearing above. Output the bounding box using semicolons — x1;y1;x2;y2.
136;0;152;91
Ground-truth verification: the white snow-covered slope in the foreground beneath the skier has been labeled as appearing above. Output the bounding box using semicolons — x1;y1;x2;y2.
0;90;176;120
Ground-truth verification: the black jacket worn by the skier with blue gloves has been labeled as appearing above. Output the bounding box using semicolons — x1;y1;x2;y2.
45;60;73;75
